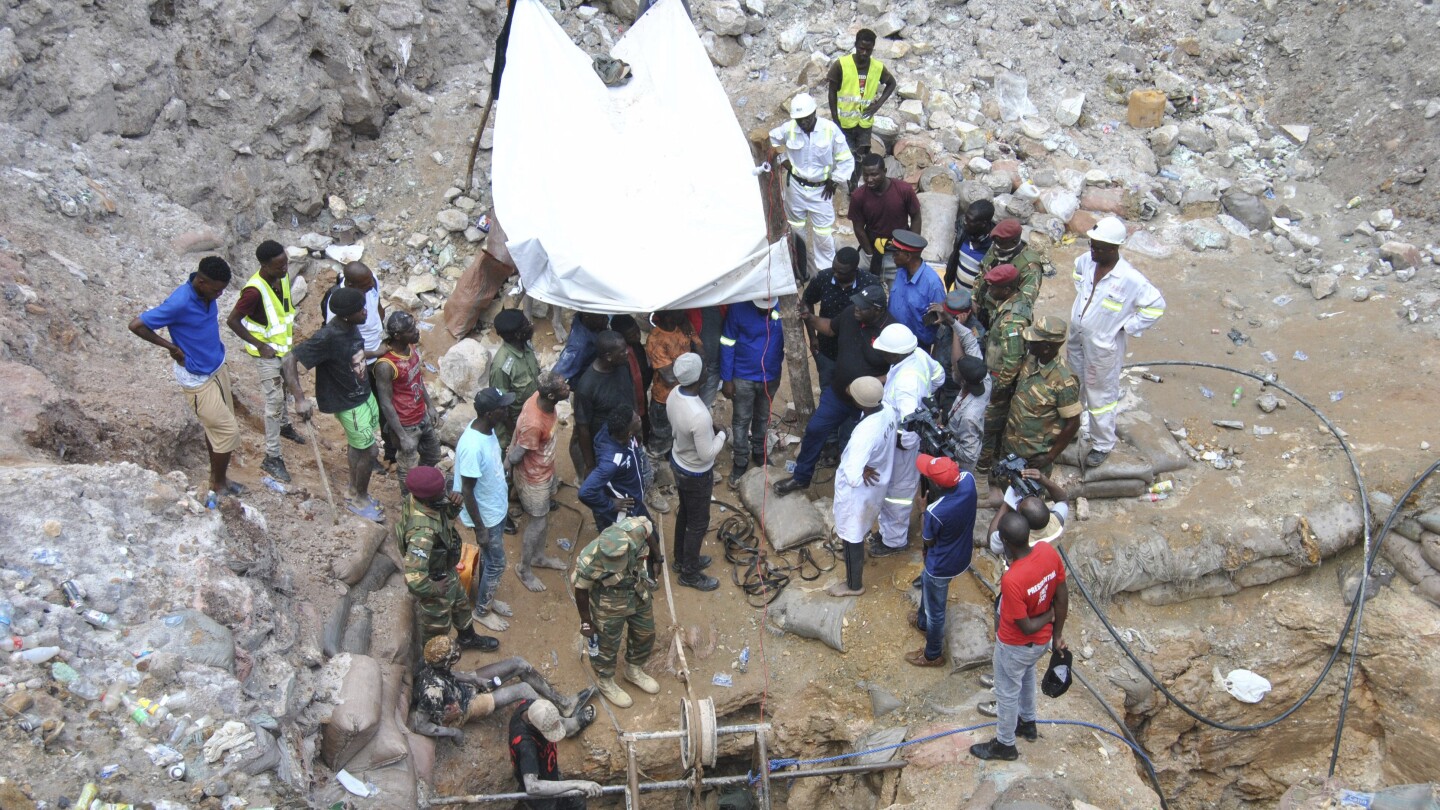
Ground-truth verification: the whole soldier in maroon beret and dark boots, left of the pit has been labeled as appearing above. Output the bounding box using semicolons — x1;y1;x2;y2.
395;467;500;651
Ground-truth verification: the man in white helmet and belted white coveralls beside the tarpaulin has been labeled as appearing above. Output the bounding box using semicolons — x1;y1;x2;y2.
770;92;855;271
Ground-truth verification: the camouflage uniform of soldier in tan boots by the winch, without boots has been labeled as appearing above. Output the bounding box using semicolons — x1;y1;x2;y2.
570;517;655;677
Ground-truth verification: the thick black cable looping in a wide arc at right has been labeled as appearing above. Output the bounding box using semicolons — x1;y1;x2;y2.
1056;360;1380;732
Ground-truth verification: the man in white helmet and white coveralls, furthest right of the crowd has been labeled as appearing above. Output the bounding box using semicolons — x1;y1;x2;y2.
1066;216;1165;467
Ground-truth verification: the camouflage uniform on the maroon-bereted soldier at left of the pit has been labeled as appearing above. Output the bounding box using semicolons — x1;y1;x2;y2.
395;496;469;644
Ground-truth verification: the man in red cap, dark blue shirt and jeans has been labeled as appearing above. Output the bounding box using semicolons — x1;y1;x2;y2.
904;454;976;666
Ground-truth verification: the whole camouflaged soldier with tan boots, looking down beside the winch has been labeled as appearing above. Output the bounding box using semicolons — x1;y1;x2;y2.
570;517;665;708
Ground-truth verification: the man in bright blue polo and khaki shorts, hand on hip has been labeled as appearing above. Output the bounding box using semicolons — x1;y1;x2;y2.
130;257;245;509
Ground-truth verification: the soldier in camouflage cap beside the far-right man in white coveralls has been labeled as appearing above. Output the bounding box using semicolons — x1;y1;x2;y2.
1001;316;1081;476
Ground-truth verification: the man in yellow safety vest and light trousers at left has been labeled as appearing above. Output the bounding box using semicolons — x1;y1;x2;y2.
225;239;305;483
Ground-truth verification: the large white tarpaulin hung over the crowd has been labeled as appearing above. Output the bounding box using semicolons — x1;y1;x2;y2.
491;0;795;313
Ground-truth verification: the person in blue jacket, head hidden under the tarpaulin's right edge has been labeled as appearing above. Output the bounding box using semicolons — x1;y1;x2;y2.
720;298;785;489
